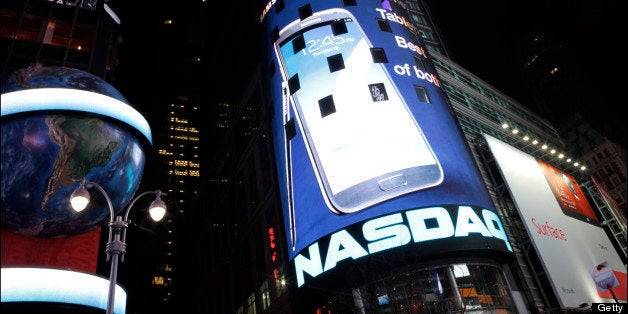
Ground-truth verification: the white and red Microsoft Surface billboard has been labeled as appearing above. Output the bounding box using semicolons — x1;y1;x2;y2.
484;135;627;309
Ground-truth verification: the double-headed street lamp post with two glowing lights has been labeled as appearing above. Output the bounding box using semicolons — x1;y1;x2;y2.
70;178;166;314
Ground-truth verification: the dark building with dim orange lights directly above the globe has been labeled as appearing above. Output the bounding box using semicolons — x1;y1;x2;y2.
2;1;120;82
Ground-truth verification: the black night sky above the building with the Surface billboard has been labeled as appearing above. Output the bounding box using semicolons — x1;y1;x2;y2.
426;0;626;147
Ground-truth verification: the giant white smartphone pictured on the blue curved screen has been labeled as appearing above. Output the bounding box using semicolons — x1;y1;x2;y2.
274;8;443;214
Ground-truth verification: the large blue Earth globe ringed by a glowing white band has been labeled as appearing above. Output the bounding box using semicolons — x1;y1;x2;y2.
0;66;152;238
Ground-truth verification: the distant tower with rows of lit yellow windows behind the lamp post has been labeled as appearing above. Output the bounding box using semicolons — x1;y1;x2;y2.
139;95;201;310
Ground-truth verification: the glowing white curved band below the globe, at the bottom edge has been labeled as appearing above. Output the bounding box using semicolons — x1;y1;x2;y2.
0;267;126;313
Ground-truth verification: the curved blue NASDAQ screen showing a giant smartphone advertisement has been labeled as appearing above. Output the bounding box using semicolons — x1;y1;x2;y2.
260;0;511;285
